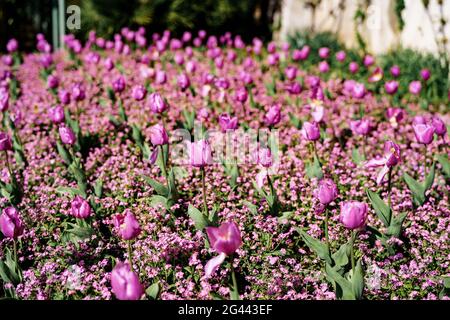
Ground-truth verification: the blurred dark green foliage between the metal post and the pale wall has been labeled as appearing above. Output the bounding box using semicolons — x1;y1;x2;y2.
68;0;281;39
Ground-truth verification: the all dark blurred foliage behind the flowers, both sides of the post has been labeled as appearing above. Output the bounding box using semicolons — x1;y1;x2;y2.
0;0;281;51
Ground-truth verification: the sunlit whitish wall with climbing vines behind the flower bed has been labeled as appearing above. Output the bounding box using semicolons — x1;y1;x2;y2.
276;0;450;54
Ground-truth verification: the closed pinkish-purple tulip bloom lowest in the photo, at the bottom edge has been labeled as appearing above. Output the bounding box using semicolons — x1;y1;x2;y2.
111;262;144;300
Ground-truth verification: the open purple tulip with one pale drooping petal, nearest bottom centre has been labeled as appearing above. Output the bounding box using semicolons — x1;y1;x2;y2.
205;222;242;278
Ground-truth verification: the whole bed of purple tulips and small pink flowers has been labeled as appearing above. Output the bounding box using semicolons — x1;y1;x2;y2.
0;29;450;300
